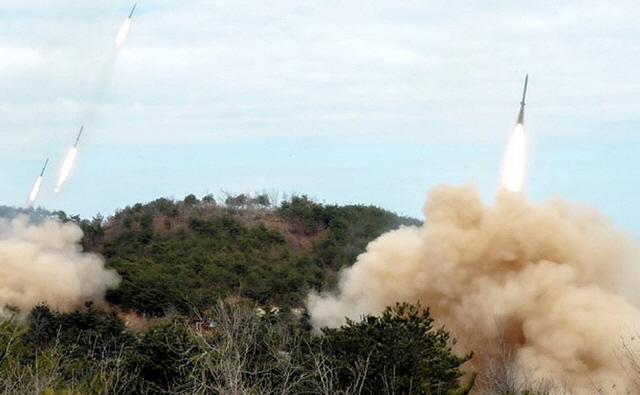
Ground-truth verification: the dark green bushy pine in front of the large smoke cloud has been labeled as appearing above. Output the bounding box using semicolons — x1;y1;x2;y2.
320;303;472;395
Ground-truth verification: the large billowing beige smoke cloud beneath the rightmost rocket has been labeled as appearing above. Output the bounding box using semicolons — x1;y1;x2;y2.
307;185;640;394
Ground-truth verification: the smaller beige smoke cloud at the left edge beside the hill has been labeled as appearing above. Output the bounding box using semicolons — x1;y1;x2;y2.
0;216;120;312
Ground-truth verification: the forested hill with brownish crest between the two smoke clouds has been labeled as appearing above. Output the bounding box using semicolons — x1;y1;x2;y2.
73;194;420;316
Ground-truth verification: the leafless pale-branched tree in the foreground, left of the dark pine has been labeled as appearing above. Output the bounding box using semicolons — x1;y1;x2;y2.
187;301;316;395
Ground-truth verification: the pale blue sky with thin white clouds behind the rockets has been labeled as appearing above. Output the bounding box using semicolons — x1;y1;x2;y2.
0;0;640;236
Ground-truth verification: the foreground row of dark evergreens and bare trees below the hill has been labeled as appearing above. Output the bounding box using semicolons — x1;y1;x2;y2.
0;301;473;395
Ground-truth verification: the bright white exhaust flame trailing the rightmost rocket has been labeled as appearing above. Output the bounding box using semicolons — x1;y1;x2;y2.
501;123;527;192
